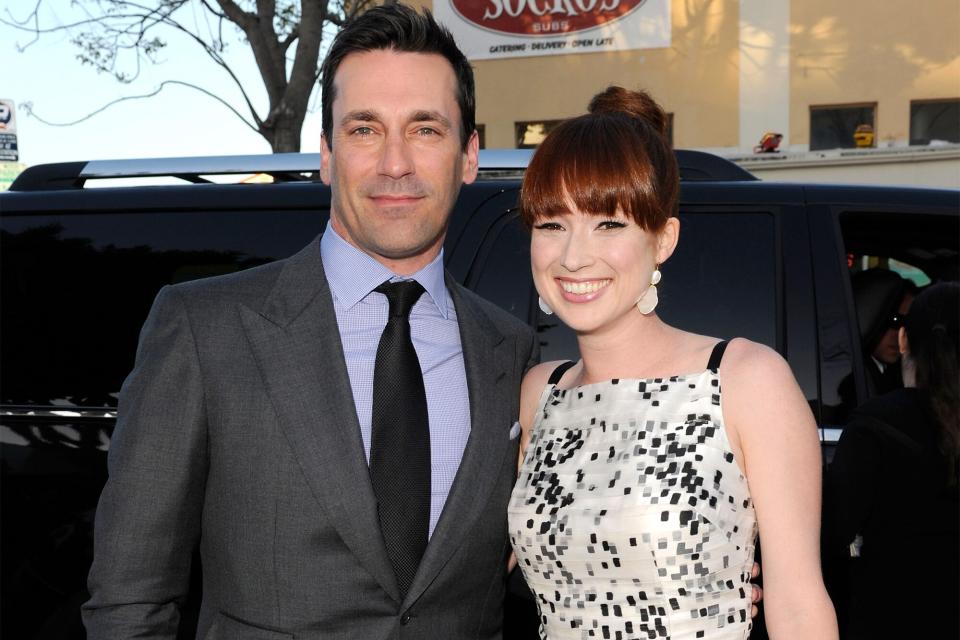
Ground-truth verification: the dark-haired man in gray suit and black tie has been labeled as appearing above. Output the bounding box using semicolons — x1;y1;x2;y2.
83;5;537;640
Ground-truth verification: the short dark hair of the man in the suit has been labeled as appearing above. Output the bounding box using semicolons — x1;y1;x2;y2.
321;3;476;148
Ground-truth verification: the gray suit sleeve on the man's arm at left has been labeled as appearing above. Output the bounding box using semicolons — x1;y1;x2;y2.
82;287;207;640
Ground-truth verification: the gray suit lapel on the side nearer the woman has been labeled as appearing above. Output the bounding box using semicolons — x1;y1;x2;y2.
406;273;520;602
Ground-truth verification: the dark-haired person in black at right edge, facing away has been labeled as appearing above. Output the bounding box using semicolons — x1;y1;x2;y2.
824;282;960;640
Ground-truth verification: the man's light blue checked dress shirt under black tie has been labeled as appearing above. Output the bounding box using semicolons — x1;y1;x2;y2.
320;224;470;535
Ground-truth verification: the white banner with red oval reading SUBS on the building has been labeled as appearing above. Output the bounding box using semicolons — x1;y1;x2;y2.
433;0;670;60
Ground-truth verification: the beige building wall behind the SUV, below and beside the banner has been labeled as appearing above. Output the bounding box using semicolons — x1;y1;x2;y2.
415;0;960;187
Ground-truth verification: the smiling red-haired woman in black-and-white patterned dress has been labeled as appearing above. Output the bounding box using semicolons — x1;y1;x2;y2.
510;87;837;640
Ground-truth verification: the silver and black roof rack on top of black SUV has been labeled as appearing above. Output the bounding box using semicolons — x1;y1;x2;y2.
10;149;757;191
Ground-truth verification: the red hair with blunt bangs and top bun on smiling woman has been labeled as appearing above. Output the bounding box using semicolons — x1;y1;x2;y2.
520;87;680;231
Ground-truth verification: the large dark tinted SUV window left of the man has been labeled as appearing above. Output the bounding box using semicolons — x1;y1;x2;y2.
0;211;324;406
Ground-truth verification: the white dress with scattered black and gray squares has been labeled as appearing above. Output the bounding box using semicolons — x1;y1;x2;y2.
509;351;757;640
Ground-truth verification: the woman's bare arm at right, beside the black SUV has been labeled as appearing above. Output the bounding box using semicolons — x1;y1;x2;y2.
720;340;838;640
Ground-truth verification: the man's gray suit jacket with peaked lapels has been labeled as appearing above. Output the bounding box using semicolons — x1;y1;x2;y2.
83;242;537;640
